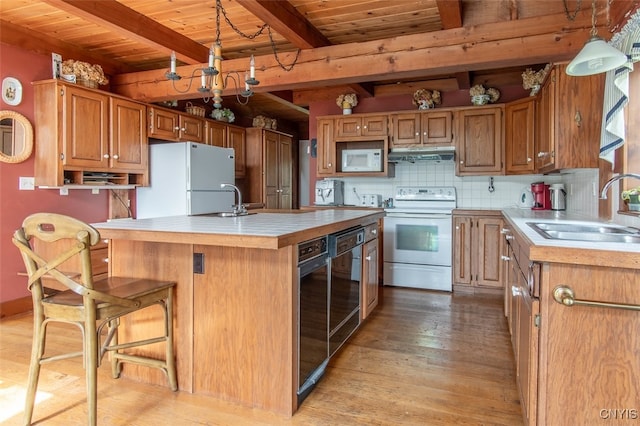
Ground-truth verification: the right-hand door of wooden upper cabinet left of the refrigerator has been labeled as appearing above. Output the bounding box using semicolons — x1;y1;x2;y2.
109;98;149;171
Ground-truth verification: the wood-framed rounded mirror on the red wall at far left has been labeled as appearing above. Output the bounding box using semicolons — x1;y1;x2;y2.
0;111;33;163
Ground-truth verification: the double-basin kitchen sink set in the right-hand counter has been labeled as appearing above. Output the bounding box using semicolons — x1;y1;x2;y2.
527;222;640;244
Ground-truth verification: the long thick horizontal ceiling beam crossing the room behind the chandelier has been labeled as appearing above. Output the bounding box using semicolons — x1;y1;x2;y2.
112;14;590;101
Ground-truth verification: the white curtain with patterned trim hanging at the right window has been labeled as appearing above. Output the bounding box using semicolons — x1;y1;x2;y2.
600;9;640;164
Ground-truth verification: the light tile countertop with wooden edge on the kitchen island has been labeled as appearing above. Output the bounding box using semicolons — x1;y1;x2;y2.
92;209;384;249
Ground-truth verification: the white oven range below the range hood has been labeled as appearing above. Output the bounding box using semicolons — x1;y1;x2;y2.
383;186;456;291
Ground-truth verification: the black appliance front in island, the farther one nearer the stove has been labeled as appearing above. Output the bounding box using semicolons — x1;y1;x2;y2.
329;226;364;356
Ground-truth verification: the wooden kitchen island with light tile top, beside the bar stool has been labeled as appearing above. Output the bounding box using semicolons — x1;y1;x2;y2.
93;210;384;416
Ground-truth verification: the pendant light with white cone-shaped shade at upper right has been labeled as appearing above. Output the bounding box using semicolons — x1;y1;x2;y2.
566;0;627;76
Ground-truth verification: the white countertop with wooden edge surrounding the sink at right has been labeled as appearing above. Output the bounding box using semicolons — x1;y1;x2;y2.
502;209;640;269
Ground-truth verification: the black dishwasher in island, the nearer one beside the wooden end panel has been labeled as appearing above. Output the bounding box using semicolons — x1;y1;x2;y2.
297;237;329;404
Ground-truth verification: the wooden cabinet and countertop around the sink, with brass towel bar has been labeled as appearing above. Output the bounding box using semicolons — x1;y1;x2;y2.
503;209;640;425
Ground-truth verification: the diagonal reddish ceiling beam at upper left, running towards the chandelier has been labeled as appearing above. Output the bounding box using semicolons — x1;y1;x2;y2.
44;0;209;64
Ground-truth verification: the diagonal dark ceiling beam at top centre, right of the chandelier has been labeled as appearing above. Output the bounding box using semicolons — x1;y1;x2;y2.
236;0;331;49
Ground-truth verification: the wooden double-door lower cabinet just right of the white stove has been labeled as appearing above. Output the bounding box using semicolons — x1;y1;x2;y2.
453;210;503;291
